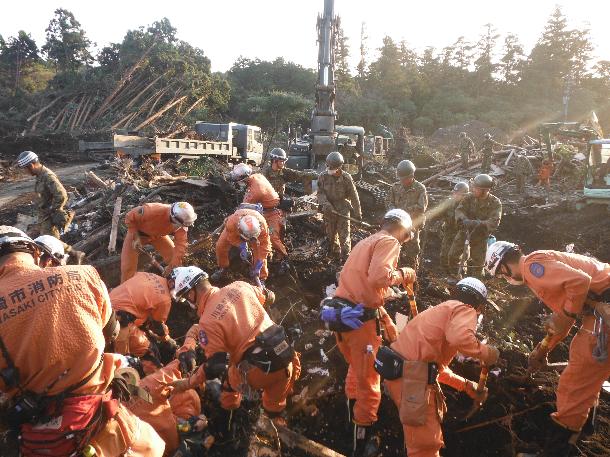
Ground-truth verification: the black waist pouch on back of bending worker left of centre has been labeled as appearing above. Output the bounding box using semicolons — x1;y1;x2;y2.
243;324;295;374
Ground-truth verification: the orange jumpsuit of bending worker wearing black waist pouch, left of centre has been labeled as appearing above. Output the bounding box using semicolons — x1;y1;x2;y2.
198;281;301;413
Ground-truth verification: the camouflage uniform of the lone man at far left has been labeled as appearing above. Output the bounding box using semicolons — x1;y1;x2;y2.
34;166;73;251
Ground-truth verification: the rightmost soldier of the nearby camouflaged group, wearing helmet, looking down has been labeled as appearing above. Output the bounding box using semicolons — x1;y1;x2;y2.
449;174;502;278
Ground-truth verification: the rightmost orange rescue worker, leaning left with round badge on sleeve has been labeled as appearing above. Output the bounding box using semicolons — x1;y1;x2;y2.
485;241;610;455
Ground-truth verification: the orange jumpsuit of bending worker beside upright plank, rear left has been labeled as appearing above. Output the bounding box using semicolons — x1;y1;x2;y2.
121;203;188;282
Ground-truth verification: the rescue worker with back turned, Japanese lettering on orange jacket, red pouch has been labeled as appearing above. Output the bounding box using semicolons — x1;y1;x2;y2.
0;226;165;457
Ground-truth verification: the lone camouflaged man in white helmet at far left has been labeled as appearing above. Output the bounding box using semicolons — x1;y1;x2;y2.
17;151;84;263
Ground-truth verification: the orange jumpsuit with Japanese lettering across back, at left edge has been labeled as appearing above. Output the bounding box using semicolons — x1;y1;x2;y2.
0;253;165;457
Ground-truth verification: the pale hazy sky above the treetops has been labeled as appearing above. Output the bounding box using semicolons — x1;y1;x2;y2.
0;0;610;71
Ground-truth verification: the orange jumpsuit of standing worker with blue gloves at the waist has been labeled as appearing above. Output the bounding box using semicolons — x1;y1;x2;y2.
335;231;403;426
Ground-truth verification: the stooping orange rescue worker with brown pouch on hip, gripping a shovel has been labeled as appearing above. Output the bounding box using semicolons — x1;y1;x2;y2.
375;278;499;457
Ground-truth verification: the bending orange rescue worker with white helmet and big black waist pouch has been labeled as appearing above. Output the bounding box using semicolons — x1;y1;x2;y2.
167;267;301;437
